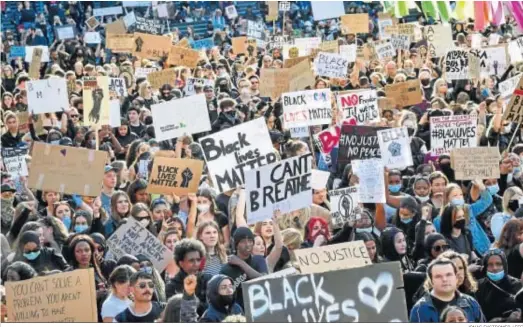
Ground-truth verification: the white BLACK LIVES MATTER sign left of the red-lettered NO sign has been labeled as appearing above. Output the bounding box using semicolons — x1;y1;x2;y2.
282;89;332;129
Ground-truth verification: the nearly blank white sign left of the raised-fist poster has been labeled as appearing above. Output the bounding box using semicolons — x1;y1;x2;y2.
26;77;68;114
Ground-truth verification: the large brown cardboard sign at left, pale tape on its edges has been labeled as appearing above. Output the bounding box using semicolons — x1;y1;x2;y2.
28;142;107;196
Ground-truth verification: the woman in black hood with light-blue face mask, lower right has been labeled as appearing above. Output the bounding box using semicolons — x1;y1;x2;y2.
476;249;523;321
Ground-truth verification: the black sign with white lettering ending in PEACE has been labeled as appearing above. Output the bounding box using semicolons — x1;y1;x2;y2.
338;125;386;165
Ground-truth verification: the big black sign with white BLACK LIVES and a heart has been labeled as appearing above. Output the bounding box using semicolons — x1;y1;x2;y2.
242;262;408;323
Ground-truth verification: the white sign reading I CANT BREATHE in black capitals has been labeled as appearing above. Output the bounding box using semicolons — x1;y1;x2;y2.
245;154;312;225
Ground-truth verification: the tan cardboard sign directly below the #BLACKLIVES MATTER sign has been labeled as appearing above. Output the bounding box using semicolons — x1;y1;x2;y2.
450;147;500;181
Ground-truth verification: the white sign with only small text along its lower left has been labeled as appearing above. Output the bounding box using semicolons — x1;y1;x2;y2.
151;94;211;141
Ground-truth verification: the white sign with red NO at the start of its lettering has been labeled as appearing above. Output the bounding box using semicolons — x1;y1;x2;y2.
336;90;380;125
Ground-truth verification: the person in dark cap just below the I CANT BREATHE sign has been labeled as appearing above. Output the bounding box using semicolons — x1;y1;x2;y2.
220;227;268;308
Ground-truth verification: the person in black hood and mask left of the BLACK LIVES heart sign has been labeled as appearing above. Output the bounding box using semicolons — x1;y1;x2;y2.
200;274;243;322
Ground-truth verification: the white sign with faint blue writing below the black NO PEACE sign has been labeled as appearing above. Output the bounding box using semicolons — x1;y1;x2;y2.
351;159;385;203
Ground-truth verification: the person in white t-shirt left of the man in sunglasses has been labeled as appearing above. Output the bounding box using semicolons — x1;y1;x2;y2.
102;265;136;322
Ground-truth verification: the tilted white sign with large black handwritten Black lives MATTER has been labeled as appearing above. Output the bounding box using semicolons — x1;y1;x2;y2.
200;118;277;193
